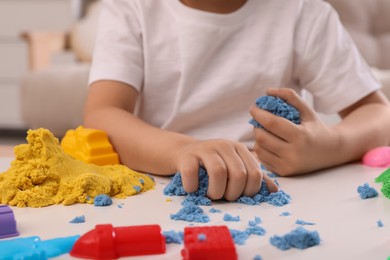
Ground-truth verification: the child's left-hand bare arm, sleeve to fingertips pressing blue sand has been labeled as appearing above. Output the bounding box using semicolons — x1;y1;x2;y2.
85;81;277;200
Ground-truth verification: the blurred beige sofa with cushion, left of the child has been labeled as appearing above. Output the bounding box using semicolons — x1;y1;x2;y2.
21;0;100;137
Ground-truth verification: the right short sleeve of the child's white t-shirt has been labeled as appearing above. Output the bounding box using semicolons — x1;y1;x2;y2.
293;1;381;113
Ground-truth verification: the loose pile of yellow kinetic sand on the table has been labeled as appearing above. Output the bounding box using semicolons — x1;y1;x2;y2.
0;128;155;207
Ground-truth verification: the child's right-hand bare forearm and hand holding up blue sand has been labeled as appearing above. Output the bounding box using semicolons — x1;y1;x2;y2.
250;89;390;176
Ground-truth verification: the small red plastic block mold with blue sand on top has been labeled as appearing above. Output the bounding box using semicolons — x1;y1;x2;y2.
181;226;237;260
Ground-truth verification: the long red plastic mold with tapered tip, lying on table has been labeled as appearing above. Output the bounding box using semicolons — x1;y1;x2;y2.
70;224;165;259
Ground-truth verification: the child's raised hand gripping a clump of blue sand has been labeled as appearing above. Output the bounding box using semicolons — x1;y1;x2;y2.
250;88;339;176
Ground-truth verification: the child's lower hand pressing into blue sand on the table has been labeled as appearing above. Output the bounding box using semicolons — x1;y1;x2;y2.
175;140;278;201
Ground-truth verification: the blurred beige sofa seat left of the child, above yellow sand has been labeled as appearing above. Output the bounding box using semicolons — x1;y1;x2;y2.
21;63;90;137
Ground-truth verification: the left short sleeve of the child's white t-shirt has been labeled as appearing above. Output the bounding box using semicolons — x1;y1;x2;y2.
89;0;144;91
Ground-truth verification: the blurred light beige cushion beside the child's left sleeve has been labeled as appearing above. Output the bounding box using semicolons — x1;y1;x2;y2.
70;1;101;62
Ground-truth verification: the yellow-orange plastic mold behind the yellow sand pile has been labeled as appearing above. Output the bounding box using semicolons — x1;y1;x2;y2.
61;126;119;165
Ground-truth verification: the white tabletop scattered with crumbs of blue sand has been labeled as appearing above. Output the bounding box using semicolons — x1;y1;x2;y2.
0;152;390;260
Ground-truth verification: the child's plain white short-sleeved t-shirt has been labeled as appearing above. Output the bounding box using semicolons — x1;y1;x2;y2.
89;0;380;147
